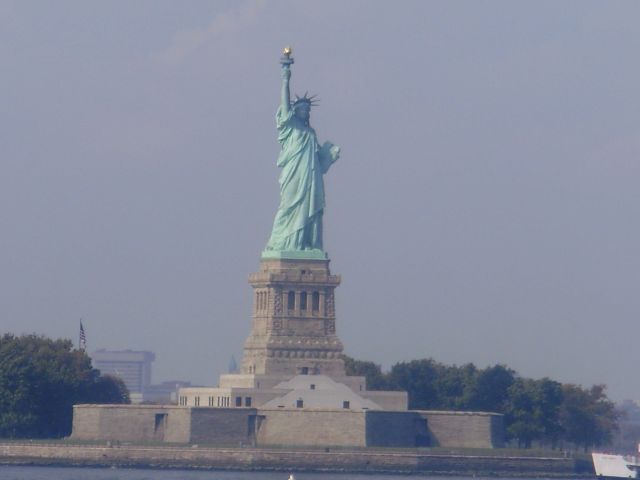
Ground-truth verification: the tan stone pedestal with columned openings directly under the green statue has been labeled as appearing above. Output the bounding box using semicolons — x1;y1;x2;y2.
241;258;345;378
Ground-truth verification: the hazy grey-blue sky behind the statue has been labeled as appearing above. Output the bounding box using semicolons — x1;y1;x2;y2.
0;0;640;400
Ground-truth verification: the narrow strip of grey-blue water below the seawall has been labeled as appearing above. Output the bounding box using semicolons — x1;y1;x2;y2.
0;465;593;480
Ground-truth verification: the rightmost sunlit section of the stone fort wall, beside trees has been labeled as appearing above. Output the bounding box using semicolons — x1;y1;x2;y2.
417;410;504;448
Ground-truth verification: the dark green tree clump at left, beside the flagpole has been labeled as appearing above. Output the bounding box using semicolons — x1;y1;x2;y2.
0;334;129;438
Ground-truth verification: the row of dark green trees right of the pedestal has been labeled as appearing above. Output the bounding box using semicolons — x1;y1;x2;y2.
344;356;618;450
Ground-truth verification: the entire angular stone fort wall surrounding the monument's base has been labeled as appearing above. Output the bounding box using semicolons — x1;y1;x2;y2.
72;405;504;448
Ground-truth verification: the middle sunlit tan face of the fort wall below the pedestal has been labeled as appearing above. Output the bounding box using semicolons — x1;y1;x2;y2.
257;409;366;447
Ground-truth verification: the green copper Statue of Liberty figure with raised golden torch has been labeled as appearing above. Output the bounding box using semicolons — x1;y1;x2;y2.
262;47;340;259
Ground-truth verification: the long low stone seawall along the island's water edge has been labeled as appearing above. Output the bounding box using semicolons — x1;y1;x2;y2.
0;443;592;477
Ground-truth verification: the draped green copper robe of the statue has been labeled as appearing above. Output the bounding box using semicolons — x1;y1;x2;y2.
266;107;334;252
